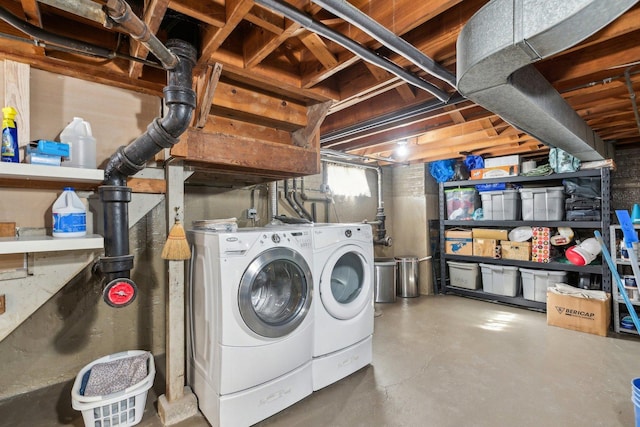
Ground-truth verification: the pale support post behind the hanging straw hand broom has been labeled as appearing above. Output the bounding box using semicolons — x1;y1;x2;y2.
158;162;198;425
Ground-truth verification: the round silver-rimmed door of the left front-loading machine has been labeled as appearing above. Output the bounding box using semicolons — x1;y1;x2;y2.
238;248;313;338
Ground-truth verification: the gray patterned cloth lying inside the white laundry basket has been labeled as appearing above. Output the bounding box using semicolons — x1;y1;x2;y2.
84;353;149;396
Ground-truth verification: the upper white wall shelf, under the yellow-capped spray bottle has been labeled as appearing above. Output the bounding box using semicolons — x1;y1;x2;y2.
0;162;104;183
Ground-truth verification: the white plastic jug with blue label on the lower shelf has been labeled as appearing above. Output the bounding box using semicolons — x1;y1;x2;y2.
51;187;87;237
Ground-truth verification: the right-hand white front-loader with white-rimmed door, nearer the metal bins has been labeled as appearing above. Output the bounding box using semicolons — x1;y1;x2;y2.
312;224;374;391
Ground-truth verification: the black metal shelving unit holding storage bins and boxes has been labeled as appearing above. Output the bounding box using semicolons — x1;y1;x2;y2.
439;168;612;310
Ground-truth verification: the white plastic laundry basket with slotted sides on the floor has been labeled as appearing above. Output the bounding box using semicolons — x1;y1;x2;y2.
71;350;156;427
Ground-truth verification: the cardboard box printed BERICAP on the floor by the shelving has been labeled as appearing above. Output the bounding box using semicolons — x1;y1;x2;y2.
547;292;611;337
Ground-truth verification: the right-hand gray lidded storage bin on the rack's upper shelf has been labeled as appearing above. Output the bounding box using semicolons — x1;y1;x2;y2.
520;187;564;221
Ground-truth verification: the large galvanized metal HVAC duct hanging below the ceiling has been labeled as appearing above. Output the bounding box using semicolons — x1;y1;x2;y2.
457;0;637;161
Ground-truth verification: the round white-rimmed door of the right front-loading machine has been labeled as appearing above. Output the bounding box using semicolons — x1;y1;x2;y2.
320;245;372;320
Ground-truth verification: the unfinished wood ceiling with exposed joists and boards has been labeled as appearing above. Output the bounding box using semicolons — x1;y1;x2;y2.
0;0;640;163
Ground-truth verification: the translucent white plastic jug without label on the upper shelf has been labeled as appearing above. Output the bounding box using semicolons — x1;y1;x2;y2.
60;117;96;169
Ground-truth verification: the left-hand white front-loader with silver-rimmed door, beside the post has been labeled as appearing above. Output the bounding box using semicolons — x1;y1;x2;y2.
187;227;314;427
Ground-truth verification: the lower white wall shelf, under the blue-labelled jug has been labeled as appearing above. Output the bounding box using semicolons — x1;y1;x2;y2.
0;234;104;254
